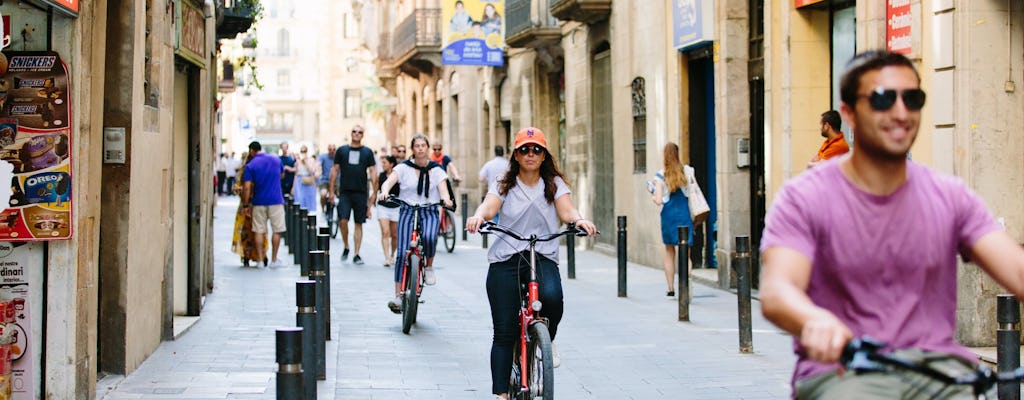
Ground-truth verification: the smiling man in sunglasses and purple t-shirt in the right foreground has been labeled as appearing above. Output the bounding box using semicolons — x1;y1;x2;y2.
761;51;1024;398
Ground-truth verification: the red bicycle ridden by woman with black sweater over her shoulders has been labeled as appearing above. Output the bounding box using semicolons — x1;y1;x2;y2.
387;195;444;335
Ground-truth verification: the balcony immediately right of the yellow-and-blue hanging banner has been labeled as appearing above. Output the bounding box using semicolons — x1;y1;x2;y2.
505;0;562;48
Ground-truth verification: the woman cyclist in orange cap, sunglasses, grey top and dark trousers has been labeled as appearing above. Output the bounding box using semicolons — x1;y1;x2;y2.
466;128;597;399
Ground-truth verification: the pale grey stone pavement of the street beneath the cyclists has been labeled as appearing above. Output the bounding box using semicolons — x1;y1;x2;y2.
97;197;795;400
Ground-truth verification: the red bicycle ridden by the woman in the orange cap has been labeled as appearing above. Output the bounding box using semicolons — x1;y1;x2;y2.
478;221;587;400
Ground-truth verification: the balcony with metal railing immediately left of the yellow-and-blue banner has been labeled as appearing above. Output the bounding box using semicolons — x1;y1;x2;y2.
382;8;441;74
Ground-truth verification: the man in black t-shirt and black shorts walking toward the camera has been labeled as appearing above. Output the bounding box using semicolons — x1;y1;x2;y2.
330;125;377;265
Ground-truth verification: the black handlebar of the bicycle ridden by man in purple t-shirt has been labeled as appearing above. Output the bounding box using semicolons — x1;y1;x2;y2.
840;336;1024;399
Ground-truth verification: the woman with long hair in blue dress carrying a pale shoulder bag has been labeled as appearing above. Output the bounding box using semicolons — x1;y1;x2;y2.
650;142;693;299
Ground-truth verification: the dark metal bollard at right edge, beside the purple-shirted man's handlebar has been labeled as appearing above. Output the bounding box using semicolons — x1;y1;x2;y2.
995;295;1021;400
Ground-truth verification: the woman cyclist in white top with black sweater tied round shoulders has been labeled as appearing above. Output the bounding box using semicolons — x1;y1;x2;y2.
377;133;452;314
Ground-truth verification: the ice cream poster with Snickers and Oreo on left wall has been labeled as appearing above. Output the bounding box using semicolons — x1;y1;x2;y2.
0;51;73;241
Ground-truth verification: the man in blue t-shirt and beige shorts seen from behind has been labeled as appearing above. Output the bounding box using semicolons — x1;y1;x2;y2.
242;141;286;267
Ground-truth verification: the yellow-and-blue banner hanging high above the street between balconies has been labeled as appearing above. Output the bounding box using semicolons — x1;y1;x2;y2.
441;0;505;66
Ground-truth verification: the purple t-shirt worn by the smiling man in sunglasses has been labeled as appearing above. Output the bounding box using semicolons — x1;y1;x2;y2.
761;162;999;382
